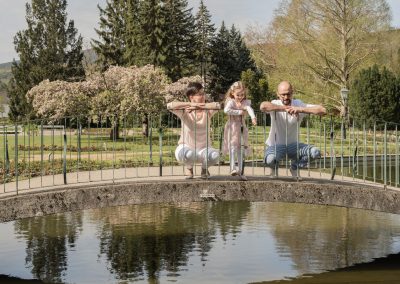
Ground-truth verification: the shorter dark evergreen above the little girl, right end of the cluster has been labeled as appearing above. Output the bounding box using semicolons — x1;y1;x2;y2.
209;23;256;99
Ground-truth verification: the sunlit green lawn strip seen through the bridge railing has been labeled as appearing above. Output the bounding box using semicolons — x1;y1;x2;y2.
0;127;398;160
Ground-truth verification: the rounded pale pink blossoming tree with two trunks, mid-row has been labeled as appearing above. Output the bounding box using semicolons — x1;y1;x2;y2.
88;65;169;139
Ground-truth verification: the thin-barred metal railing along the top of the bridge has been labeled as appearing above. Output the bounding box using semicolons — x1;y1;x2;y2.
0;111;400;194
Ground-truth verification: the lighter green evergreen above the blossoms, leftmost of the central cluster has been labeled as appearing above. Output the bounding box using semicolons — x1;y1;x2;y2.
92;0;127;71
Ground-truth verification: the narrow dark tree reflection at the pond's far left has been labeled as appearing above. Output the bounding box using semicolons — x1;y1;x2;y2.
15;213;82;283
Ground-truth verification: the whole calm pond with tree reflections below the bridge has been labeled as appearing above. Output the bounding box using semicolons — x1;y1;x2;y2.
0;201;400;283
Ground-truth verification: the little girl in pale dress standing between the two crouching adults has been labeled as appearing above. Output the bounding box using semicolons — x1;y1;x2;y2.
223;81;257;180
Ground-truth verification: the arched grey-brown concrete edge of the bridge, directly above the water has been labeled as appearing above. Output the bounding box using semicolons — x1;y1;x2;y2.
0;180;400;222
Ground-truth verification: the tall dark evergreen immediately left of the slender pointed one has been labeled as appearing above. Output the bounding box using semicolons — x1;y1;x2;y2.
162;0;196;81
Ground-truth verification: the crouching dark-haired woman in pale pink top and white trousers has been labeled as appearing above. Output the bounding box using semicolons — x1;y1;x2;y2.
167;83;221;179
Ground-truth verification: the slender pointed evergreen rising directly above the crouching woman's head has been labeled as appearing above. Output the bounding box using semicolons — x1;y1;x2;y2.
195;0;216;81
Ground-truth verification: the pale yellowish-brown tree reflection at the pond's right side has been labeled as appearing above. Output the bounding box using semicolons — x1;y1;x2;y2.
264;203;400;273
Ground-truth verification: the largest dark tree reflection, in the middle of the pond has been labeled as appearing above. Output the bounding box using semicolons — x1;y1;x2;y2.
92;202;250;283
